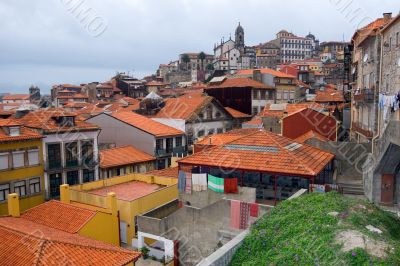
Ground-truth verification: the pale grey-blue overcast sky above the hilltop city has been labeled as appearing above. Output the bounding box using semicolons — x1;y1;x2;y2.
0;0;400;93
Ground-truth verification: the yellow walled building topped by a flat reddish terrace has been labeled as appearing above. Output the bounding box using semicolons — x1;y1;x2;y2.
70;174;178;245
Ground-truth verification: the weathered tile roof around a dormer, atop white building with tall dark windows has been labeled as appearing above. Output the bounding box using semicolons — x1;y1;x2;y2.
16;108;99;133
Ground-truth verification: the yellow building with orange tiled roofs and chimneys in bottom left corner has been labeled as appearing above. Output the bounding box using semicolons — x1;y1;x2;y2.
0;192;141;266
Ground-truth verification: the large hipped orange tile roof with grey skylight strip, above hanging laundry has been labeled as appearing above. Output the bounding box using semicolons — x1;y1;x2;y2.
178;131;334;177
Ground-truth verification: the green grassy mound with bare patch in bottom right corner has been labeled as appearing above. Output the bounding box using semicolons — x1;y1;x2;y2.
231;193;400;265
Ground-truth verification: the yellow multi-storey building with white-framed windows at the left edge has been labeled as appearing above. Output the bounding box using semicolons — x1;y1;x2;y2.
0;119;44;215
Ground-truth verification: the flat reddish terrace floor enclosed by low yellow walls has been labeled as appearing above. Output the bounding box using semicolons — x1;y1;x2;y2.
88;181;163;201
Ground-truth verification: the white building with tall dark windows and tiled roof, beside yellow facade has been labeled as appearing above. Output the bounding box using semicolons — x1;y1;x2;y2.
18;109;100;198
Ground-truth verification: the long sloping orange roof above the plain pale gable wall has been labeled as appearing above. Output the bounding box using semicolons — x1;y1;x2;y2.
111;112;185;137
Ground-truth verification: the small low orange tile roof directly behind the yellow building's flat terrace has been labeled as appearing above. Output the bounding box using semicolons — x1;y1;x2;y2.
100;145;156;168
